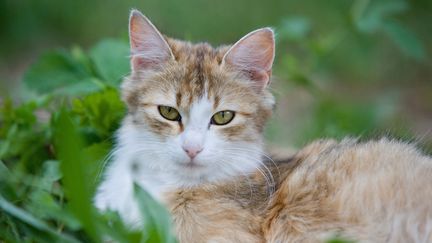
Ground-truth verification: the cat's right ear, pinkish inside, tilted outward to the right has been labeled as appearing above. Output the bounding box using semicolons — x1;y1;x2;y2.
222;28;275;91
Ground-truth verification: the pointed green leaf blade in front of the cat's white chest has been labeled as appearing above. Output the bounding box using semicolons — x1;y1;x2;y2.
134;184;176;243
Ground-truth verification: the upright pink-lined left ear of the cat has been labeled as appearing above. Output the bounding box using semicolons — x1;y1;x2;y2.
129;10;174;71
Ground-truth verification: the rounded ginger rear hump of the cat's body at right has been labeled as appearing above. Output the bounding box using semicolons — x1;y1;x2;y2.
263;139;432;242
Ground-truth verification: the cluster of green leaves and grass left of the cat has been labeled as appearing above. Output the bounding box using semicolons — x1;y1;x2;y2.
0;40;175;242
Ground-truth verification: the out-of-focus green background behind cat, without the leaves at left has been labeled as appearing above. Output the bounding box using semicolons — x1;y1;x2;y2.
0;0;432;148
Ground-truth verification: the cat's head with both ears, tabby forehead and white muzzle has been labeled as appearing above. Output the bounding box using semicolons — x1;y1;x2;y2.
119;10;275;186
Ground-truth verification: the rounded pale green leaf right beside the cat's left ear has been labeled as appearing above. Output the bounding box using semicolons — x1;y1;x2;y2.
90;39;130;86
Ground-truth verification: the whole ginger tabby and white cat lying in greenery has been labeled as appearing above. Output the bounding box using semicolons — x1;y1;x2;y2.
94;10;432;242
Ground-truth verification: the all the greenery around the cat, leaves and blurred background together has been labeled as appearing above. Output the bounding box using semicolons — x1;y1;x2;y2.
0;0;432;242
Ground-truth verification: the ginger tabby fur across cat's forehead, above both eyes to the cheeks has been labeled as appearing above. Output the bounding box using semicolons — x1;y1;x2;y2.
123;39;263;113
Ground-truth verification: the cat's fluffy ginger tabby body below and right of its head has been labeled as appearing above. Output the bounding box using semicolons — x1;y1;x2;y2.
166;139;432;242
